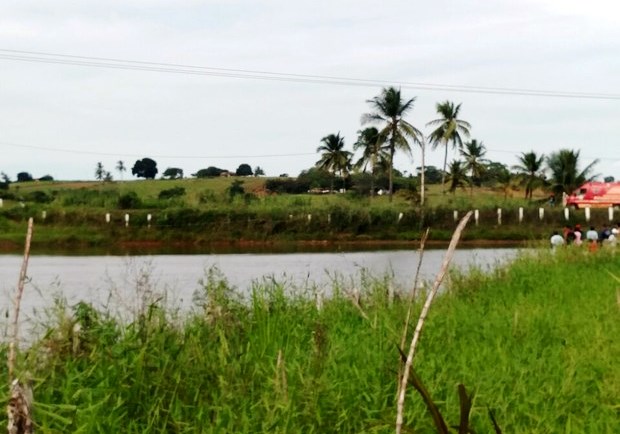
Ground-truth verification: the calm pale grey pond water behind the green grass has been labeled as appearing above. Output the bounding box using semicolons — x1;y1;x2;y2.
0;248;517;324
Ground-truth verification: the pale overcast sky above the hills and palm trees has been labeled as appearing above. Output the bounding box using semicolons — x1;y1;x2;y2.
0;0;620;180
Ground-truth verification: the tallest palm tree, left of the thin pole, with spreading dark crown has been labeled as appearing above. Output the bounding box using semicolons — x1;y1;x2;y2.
362;87;422;201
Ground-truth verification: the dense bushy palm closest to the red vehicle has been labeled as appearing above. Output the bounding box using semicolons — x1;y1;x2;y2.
547;149;598;194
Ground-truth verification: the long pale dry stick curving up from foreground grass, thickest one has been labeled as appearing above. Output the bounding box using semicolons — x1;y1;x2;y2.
396;211;472;434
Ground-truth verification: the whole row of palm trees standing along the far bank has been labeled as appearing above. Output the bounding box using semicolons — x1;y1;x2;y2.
315;87;613;204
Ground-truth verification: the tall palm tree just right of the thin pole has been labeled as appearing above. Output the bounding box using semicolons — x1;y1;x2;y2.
426;101;471;193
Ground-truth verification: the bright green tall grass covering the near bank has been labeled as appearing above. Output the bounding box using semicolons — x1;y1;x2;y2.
5;249;620;433
